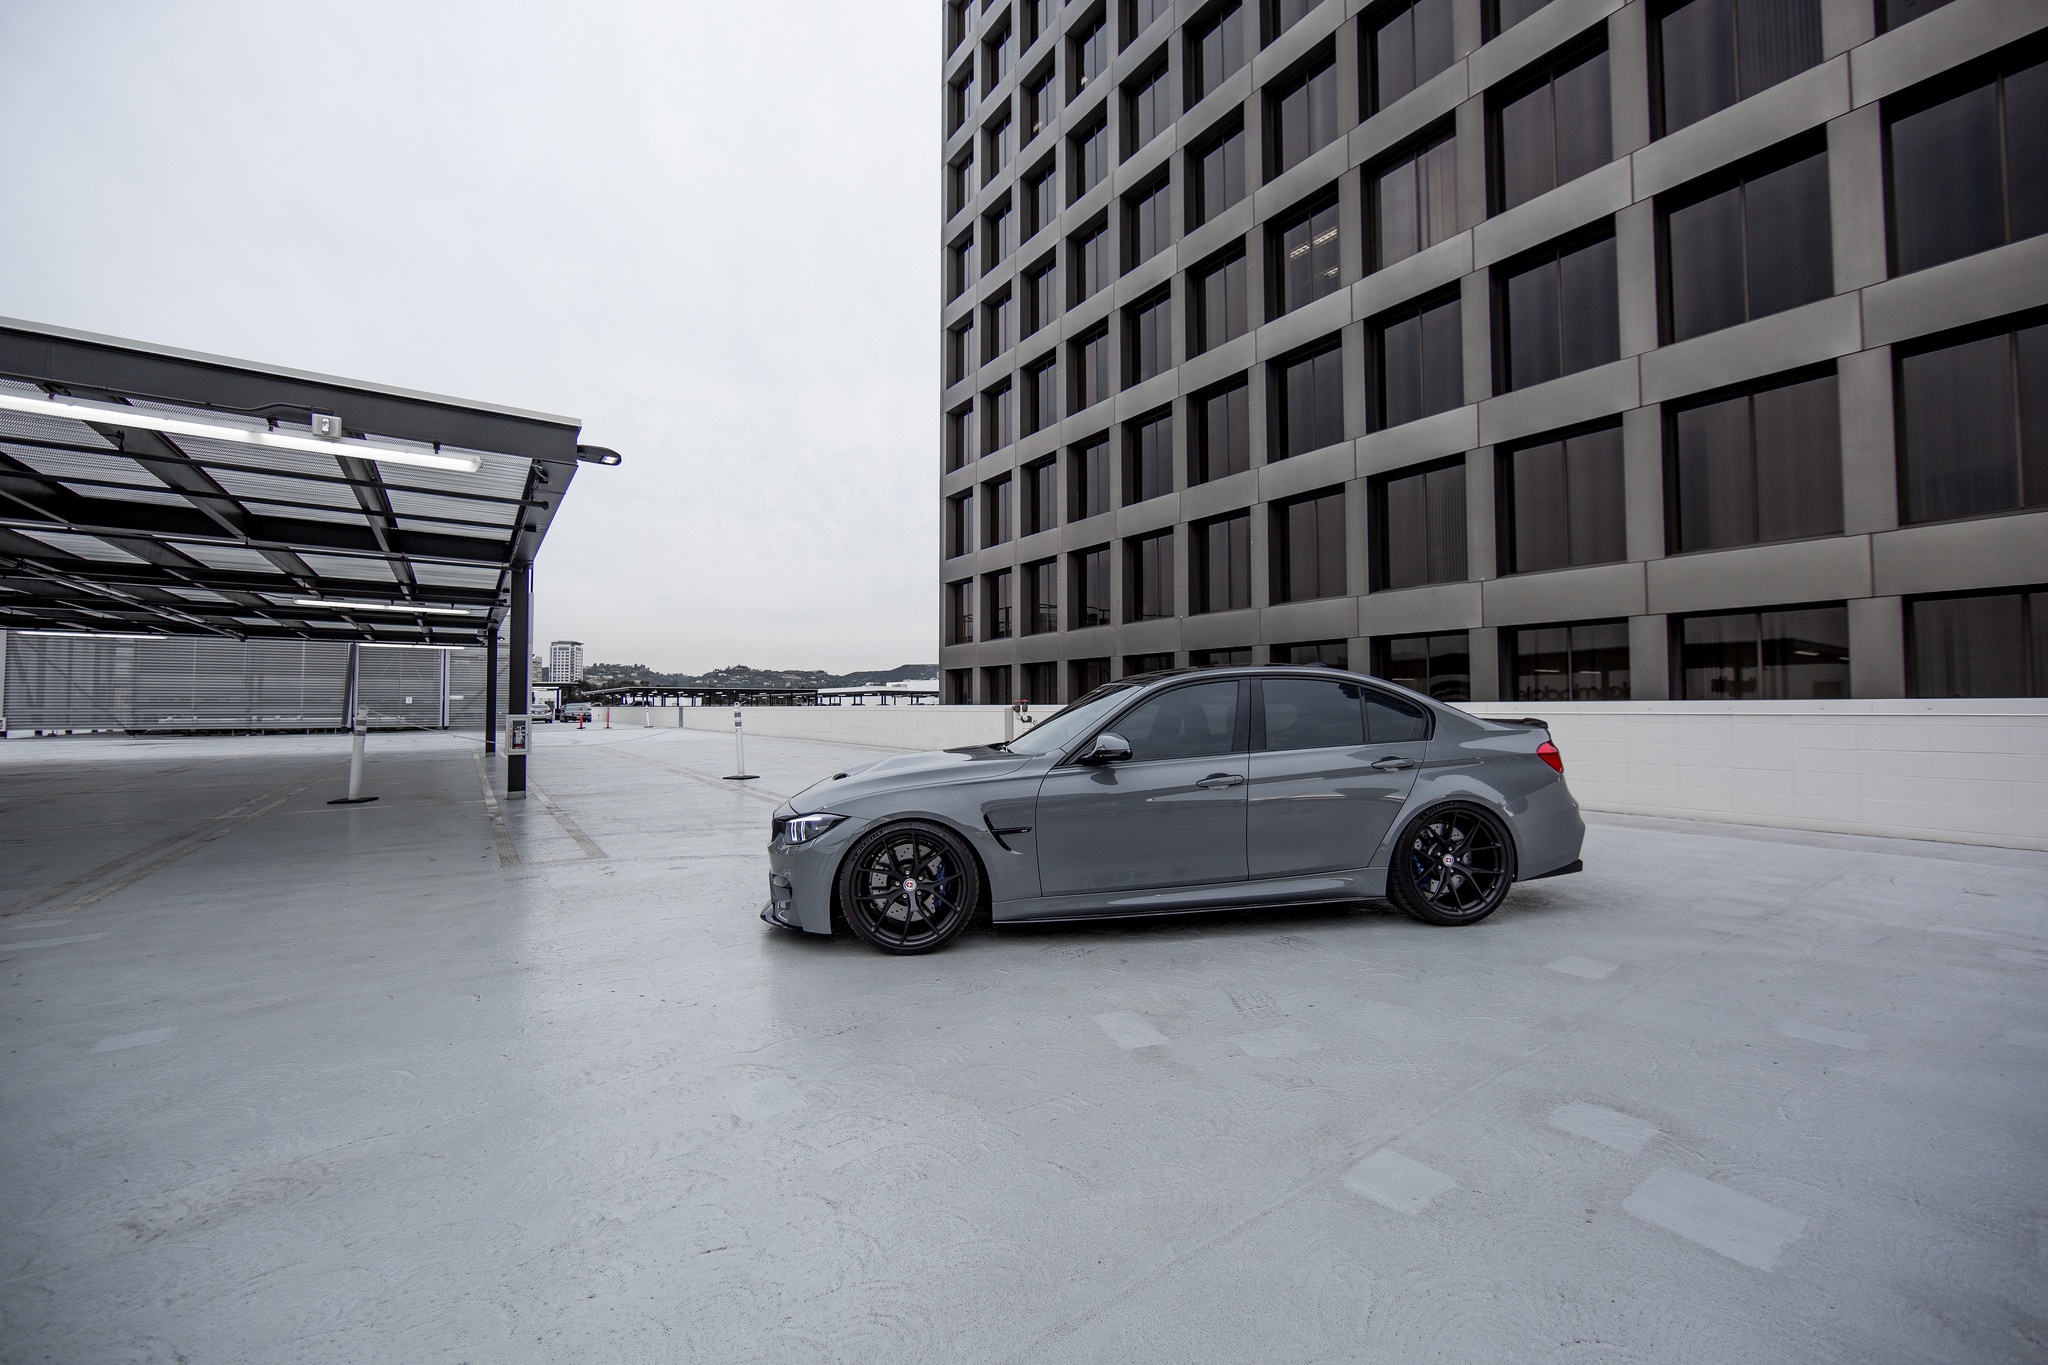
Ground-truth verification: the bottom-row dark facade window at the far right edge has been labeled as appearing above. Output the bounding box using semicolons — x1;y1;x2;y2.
1907;587;2048;696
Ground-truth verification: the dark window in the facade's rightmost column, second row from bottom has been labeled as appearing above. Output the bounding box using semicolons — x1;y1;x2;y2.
1892;317;2048;522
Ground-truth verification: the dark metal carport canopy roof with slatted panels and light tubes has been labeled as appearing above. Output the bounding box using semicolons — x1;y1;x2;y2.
0;319;618;645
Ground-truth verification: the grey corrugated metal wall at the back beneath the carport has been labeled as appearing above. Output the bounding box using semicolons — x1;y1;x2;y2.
0;630;510;731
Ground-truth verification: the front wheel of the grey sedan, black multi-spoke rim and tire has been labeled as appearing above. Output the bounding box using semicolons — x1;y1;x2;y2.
840;821;981;956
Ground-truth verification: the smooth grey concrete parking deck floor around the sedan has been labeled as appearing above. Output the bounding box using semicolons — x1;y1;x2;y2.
0;729;2048;1365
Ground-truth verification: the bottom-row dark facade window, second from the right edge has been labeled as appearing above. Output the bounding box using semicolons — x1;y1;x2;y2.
1677;604;1849;702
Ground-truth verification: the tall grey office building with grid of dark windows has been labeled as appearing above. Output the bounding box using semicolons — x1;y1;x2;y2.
940;0;2048;702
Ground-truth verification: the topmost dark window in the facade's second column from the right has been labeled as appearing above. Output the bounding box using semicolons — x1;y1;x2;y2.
1653;0;1821;133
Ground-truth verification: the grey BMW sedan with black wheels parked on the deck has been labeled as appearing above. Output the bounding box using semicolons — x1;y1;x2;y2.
762;667;1585;954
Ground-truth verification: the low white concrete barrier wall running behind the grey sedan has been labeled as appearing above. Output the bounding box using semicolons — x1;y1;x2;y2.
675;700;2048;849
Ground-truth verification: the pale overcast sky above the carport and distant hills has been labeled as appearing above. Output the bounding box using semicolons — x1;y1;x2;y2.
0;0;940;673
